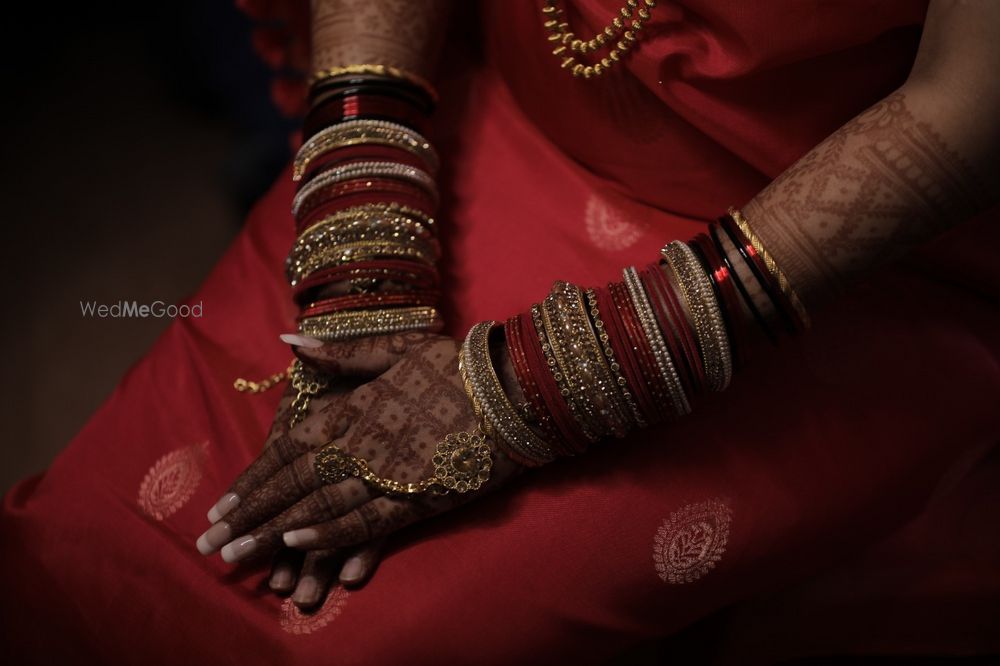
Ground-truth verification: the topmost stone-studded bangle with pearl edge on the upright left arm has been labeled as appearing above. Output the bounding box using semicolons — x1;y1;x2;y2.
292;119;438;180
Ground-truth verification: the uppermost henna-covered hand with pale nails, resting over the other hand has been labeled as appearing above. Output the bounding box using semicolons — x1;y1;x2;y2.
202;333;521;600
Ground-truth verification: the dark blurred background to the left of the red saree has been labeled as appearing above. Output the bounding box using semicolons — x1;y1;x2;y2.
0;0;294;492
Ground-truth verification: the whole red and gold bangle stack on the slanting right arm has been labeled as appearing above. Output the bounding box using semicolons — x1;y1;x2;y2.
461;209;809;466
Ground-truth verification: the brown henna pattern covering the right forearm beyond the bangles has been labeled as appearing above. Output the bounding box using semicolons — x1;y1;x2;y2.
744;92;984;300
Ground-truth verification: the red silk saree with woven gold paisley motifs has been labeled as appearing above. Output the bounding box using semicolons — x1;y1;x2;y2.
0;0;1000;664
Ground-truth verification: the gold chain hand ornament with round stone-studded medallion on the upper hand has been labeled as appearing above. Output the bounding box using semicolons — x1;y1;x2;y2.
314;427;493;495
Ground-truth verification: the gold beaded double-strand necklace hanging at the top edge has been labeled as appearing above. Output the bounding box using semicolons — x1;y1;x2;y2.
542;0;656;79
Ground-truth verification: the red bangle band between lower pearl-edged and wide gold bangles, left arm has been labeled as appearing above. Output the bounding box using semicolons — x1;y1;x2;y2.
295;178;435;234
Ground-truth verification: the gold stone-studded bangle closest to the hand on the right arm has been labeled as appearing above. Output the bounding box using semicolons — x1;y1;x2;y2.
461;321;555;466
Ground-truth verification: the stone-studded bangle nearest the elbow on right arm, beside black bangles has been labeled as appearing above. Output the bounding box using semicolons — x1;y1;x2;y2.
661;241;733;391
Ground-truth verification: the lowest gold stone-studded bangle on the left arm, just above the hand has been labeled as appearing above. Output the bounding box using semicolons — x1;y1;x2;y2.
299;306;441;341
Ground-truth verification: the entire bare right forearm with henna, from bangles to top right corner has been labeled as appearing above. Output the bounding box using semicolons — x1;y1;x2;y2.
743;0;1000;305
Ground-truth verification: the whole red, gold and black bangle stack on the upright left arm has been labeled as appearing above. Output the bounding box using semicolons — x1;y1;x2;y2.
286;64;441;340
